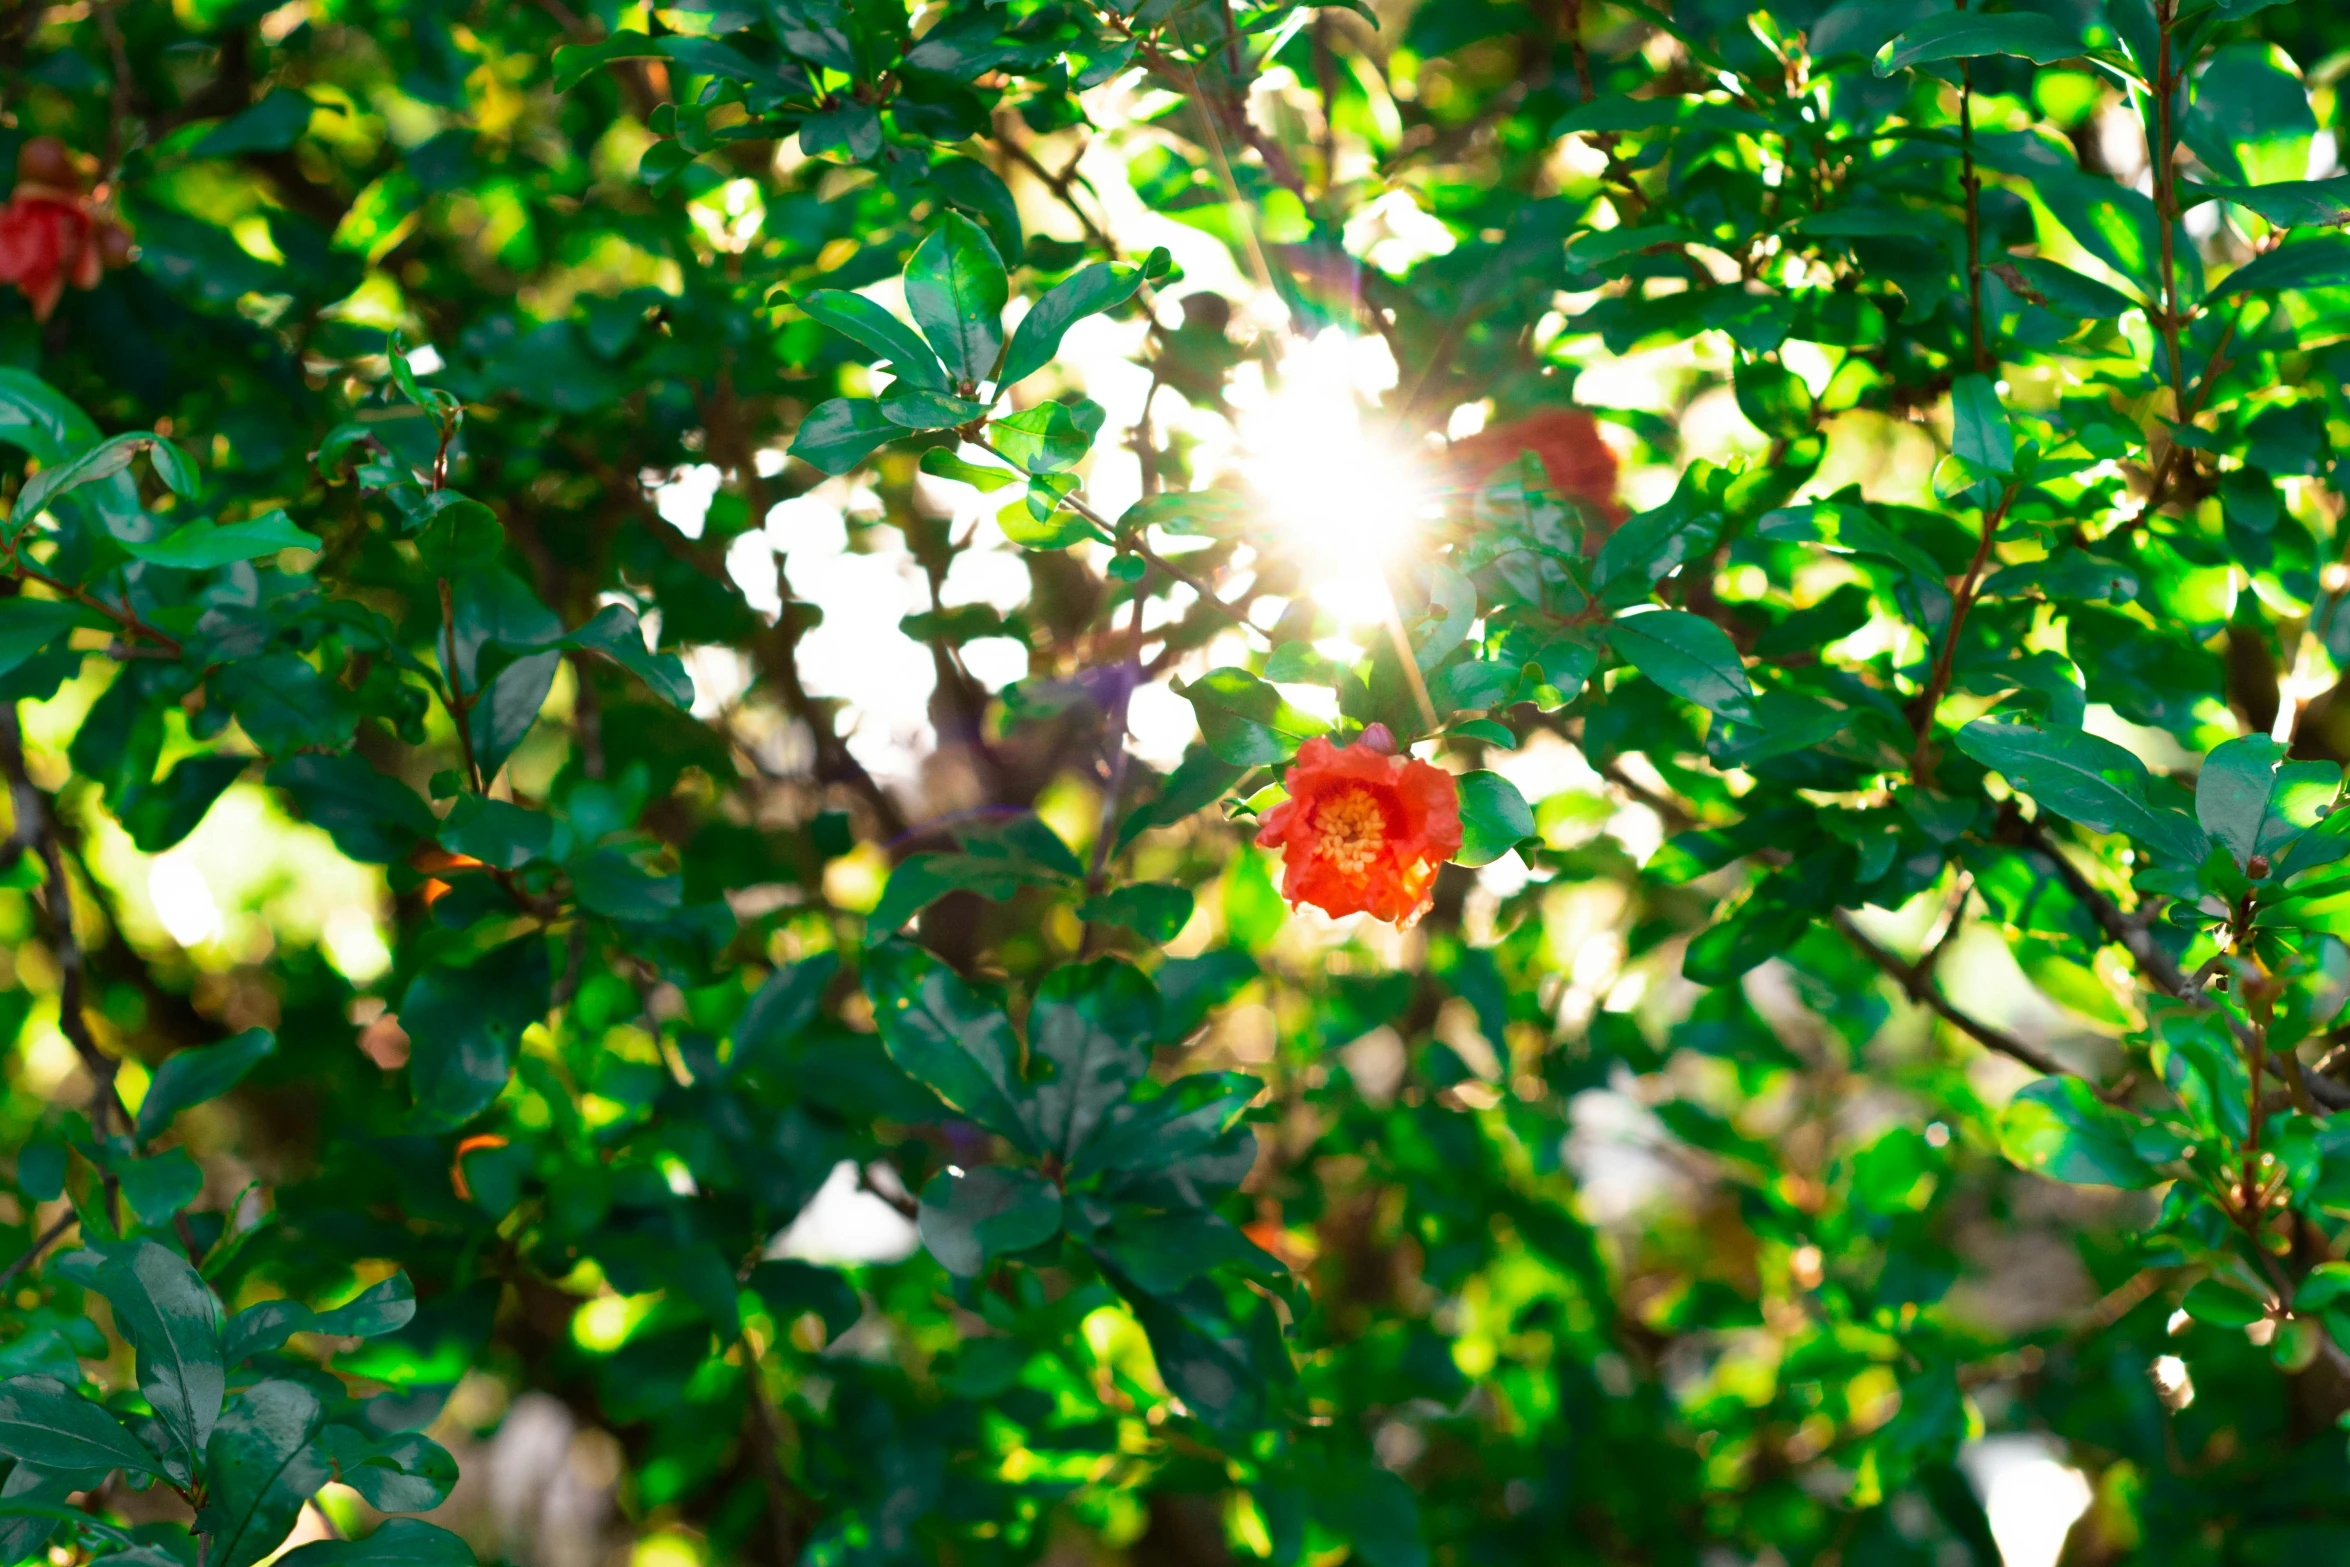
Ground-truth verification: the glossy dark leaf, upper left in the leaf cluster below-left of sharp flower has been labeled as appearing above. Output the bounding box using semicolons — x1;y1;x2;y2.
865;942;1041;1154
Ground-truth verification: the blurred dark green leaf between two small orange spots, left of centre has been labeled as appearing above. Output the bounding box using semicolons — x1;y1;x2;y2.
400;935;550;1125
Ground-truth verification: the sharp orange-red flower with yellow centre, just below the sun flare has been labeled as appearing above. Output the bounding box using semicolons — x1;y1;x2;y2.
1257;724;1462;926
